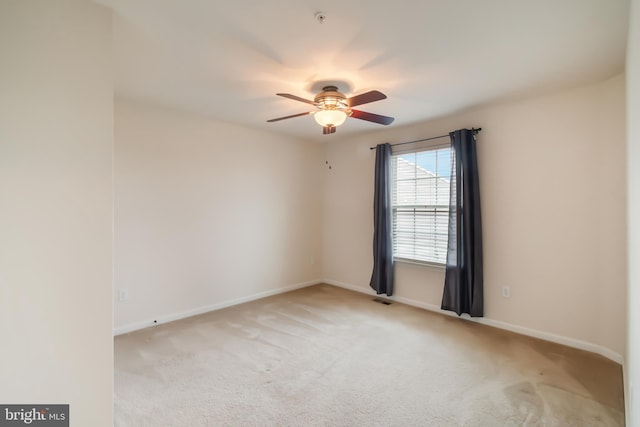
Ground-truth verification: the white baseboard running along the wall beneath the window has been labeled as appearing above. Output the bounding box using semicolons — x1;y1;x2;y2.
322;279;624;365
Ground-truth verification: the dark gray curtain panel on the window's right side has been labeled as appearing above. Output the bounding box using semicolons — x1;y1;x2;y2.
442;129;484;317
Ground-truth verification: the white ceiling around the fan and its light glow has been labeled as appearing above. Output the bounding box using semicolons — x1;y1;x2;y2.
96;0;629;140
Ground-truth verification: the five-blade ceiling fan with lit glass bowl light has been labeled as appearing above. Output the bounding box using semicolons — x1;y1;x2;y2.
267;86;394;135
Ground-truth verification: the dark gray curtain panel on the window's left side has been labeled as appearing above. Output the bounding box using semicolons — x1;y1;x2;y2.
370;144;393;296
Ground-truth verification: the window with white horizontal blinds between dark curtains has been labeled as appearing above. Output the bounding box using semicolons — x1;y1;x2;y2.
391;145;451;265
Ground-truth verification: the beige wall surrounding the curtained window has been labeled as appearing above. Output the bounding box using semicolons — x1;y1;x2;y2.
324;75;626;361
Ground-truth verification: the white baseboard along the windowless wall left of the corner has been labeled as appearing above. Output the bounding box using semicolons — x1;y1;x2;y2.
113;279;323;336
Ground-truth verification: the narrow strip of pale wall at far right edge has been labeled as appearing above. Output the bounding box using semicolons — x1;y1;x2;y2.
625;0;640;427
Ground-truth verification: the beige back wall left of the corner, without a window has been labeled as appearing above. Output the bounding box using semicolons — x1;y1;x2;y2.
115;100;323;332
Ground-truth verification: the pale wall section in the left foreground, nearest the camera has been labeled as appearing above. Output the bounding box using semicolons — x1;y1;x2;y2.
0;0;113;426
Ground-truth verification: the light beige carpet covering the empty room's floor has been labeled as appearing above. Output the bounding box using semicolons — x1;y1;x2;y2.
115;285;624;427
